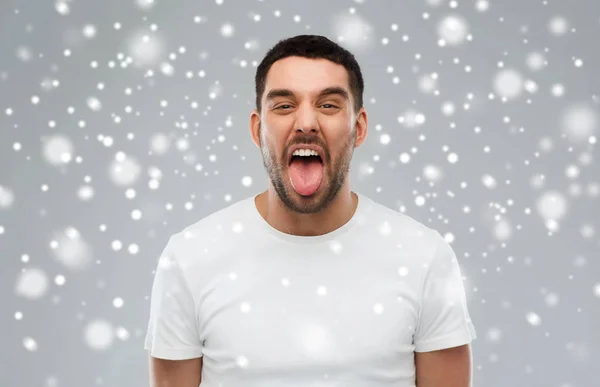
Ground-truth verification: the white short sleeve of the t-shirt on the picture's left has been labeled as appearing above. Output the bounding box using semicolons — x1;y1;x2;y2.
144;236;202;360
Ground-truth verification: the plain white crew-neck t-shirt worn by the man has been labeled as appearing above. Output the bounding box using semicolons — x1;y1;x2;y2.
145;193;476;387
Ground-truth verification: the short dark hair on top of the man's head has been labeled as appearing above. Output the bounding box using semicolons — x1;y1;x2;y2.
254;35;364;112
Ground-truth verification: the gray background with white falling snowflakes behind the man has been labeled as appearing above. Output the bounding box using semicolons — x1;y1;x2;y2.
0;0;600;387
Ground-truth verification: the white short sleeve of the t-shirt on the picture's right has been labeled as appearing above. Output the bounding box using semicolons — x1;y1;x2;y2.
414;231;477;352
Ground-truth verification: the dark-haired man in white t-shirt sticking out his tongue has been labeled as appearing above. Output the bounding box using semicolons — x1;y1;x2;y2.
145;35;476;387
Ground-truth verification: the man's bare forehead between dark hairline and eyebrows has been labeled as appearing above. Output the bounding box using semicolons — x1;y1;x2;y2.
264;57;350;95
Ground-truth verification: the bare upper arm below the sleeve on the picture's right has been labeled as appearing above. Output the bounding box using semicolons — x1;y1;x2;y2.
415;344;472;387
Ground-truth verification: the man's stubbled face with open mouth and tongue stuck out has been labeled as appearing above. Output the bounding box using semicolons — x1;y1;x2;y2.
252;57;366;214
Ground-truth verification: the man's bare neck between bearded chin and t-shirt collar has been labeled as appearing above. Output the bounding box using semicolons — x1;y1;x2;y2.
255;187;358;236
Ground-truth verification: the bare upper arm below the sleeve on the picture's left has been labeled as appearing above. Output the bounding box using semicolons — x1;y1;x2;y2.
149;356;202;387
